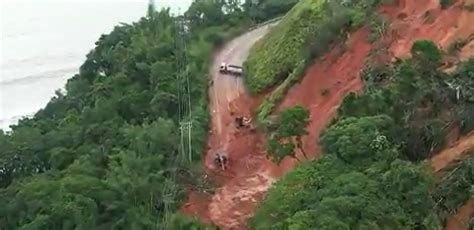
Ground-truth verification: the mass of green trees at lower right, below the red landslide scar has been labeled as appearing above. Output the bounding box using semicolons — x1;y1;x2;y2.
251;41;474;229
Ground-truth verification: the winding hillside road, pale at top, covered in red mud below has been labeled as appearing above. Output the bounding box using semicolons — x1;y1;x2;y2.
183;23;286;229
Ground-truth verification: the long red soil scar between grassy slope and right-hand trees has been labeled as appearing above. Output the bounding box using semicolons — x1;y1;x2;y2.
279;28;371;169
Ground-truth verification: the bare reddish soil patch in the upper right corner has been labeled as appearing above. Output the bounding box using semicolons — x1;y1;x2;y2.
381;0;474;57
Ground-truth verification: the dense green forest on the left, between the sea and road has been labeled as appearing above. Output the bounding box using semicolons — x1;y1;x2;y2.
0;0;294;230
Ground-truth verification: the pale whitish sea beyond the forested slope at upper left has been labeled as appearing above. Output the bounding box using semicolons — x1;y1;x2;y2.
0;0;191;130
